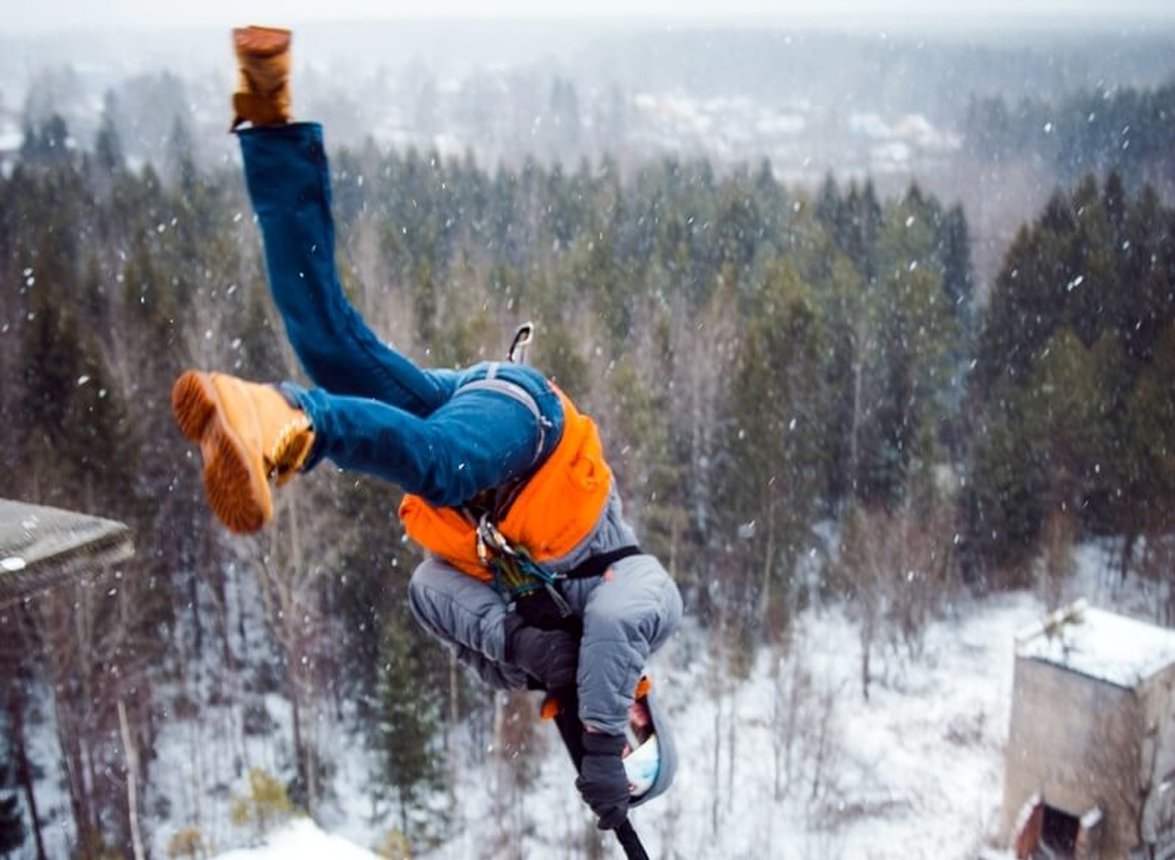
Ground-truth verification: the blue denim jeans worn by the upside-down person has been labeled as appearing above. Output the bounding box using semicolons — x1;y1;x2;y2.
240;122;563;505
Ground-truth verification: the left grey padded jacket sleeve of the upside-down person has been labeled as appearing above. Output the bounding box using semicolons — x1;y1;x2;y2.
408;557;526;690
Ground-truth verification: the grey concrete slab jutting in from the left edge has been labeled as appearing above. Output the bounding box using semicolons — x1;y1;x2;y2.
0;499;134;600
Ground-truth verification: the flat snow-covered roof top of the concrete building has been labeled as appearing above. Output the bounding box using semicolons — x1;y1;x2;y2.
1016;600;1175;690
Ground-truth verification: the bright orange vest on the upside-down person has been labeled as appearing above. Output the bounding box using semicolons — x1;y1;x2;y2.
400;388;612;582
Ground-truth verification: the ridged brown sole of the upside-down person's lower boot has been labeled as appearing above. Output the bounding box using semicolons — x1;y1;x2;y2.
172;370;273;535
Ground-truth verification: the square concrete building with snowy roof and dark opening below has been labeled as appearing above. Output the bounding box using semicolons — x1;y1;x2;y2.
1003;600;1175;860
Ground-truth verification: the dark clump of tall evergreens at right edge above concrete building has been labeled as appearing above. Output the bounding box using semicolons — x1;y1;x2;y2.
967;177;1173;565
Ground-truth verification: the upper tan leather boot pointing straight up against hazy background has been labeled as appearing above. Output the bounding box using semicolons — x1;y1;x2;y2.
230;27;293;130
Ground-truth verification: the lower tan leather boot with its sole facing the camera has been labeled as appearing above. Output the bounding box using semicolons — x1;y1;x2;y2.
172;370;314;533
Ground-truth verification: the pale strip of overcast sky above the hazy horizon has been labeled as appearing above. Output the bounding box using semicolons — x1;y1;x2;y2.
0;0;1175;33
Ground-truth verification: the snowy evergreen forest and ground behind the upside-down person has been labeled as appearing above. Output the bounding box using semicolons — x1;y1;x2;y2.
0;15;1175;860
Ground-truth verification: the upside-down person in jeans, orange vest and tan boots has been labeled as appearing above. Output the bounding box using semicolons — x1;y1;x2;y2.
172;27;682;828
